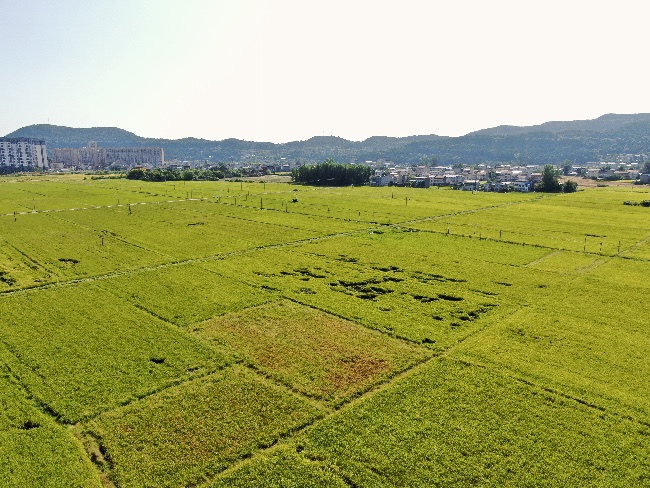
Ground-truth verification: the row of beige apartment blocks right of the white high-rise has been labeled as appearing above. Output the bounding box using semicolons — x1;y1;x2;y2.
50;142;165;169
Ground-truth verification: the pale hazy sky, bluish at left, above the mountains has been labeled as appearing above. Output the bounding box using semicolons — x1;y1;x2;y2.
0;0;650;142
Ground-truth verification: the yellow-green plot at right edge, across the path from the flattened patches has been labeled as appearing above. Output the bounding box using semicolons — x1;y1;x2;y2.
453;275;650;422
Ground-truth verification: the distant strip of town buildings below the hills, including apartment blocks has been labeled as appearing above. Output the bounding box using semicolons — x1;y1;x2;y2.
0;137;650;192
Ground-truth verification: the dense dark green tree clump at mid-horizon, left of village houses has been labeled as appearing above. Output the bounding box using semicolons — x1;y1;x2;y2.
291;159;372;186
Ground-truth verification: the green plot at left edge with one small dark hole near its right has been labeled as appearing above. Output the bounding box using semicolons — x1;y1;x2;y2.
0;284;231;423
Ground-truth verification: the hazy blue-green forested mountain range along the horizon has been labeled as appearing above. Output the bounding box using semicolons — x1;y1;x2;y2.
7;114;650;165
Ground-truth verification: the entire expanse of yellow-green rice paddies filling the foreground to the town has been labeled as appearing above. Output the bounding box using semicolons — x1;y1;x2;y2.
0;175;650;488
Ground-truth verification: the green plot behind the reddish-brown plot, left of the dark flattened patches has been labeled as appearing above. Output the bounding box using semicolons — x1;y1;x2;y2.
97;264;278;327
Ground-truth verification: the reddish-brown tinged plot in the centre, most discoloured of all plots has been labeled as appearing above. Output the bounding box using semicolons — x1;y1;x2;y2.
198;301;431;406
